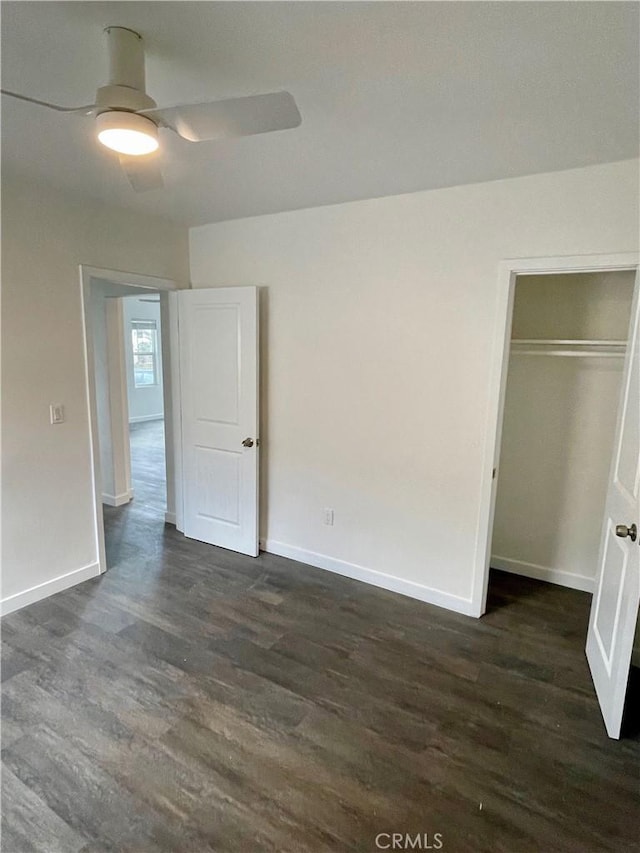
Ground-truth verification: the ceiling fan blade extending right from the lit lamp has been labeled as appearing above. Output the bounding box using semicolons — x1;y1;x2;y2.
146;92;302;142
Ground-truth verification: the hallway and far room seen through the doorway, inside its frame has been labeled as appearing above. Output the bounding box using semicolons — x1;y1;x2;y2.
90;280;167;568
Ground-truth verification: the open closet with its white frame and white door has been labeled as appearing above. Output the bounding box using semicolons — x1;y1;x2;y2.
473;253;640;738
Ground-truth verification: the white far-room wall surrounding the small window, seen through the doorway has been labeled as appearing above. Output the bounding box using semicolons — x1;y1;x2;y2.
122;296;164;423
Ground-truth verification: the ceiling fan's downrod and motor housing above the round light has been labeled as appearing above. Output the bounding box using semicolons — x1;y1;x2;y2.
96;27;157;112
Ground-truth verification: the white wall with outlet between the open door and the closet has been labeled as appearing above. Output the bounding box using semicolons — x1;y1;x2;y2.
190;161;638;611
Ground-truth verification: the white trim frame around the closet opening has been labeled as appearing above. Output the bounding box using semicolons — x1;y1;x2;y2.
471;252;640;616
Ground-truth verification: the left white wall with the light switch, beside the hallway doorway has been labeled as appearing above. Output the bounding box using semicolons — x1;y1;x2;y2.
2;175;188;611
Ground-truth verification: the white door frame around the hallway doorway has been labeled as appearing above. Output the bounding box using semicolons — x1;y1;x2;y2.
79;264;181;574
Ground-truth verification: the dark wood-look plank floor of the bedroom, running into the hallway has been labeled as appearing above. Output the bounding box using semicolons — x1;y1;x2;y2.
2;422;640;853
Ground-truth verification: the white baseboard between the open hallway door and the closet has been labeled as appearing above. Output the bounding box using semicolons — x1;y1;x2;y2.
260;539;478;616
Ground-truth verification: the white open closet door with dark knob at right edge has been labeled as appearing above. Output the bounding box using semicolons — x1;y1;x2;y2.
587;275;640;738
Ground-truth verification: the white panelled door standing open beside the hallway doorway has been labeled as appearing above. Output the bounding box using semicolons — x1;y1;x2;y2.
178;287;258;557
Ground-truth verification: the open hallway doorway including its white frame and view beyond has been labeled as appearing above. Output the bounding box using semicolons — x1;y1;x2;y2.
81;266;175;571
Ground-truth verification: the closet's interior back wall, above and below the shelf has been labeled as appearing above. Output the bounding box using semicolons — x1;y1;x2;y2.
491;272;635;591
